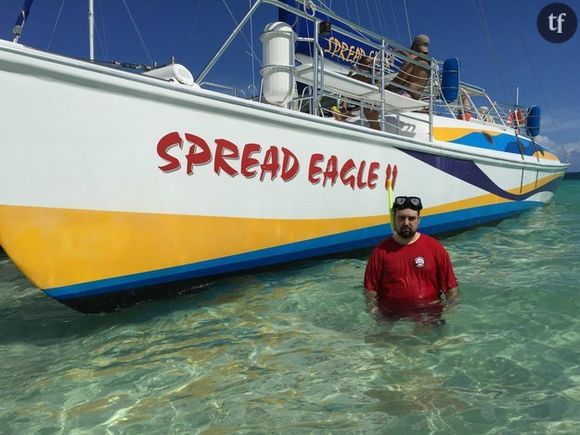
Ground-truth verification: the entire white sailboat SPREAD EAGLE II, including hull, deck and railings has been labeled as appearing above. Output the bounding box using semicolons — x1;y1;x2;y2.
0;0;567;313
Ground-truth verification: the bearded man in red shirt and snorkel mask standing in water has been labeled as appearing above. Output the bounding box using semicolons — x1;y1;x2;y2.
364;196;458;323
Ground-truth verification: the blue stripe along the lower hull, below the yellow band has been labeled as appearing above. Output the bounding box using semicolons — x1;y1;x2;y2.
46;201;543;301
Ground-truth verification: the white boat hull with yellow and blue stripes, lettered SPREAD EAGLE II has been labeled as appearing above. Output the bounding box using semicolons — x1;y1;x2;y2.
0;42;566;311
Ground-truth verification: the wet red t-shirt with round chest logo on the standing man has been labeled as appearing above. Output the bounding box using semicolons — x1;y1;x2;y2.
364;234;457;311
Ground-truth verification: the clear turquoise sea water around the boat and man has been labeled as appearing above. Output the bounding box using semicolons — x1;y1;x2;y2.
0;181;580;434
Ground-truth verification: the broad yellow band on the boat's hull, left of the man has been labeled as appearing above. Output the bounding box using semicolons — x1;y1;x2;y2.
0;205;388;289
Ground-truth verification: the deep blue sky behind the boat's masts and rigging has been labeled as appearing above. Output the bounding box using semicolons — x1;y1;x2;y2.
0;0;580;171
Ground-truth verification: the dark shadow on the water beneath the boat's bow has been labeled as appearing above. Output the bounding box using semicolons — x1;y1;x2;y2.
0;250;358;346
